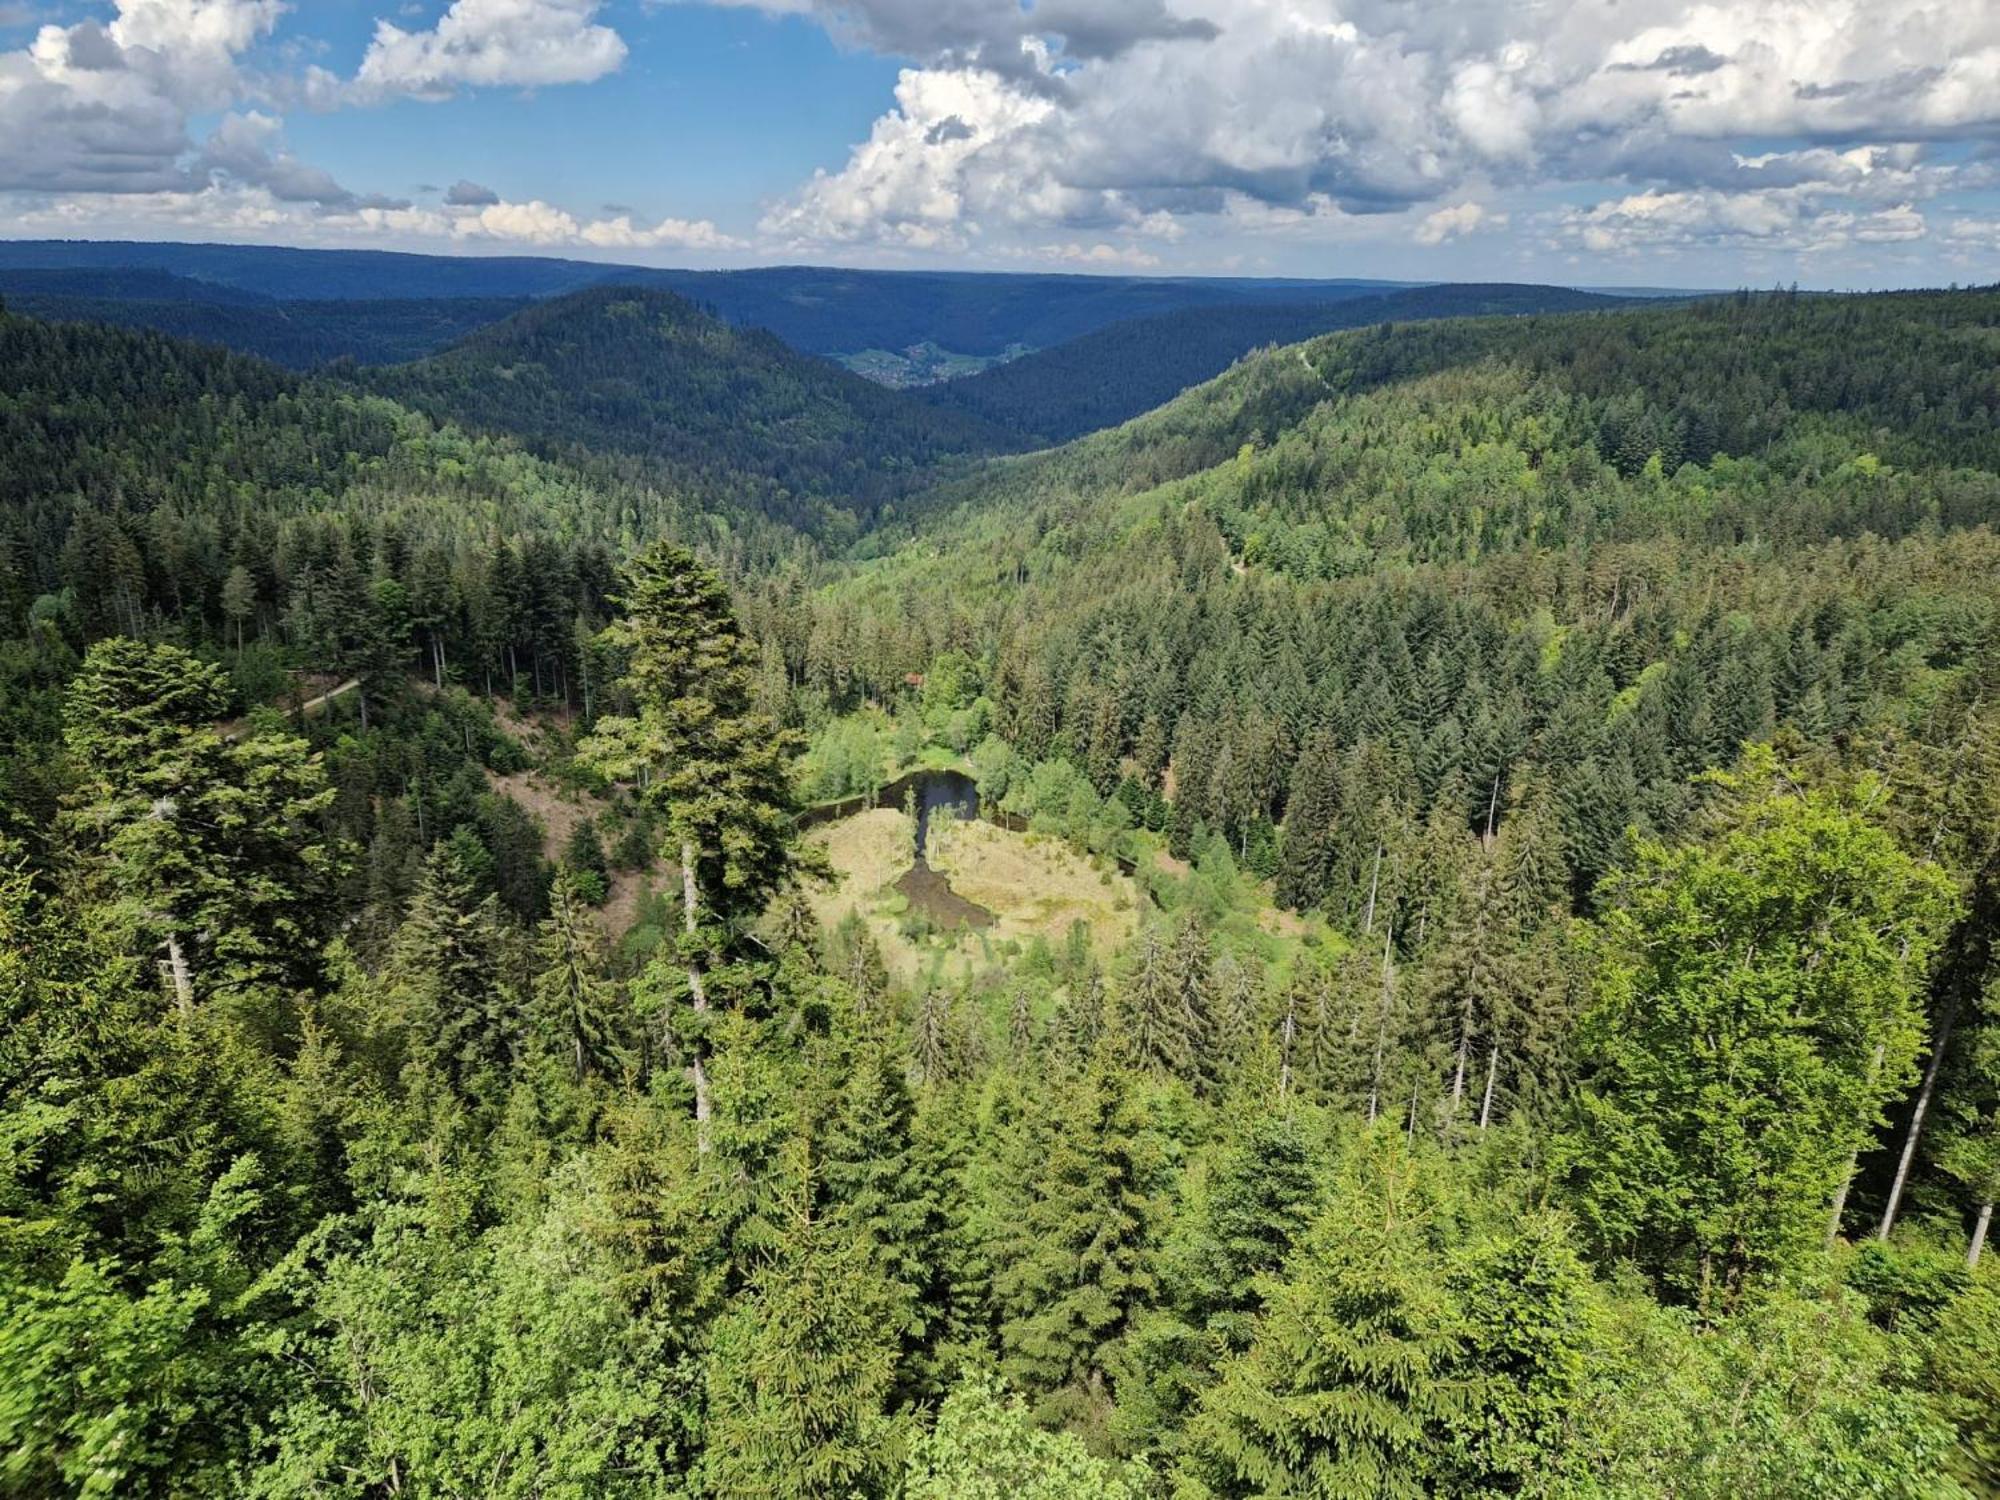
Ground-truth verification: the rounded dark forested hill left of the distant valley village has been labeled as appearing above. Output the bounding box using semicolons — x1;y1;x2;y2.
366;286;1010;524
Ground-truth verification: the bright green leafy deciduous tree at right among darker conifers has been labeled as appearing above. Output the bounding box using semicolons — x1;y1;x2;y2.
1560;758;1952;1308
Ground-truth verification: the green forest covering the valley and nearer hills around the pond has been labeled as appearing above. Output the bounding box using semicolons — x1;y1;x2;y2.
0;288;2000;1500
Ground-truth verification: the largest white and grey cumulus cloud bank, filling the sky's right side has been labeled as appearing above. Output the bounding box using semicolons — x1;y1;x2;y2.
766;0;2000;262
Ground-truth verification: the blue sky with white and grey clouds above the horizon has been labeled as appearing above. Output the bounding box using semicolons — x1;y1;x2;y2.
0;0;2000;288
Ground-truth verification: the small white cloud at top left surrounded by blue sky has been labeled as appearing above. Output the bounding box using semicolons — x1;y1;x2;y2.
354;0;626;100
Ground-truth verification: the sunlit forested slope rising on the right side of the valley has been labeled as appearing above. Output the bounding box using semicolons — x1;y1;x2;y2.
786;292;2000;912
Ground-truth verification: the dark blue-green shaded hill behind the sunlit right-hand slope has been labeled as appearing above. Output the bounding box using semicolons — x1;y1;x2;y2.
924;284;1630;444
